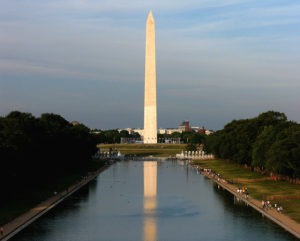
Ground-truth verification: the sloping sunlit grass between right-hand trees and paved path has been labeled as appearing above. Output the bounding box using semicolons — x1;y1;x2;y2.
194;160;300;223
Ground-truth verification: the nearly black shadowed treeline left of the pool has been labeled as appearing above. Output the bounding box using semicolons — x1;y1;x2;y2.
0;111;97;200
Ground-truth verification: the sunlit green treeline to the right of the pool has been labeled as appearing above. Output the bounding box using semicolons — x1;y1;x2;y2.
205;111;300;179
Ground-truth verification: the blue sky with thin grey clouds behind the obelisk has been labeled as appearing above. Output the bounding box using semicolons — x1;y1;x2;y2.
0;0;300;130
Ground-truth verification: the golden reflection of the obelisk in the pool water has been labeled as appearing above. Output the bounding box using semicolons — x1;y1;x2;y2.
144;161;157;241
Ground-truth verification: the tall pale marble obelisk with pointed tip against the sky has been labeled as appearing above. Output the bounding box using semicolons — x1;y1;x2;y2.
143;11;157;144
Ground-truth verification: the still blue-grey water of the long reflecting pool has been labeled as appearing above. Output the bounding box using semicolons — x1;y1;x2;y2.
11;160;297;241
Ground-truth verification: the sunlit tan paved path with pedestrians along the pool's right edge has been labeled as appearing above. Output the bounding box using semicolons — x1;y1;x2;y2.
196;167;300;239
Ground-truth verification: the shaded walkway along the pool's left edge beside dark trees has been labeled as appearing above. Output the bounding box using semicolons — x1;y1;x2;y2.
0;166;108;241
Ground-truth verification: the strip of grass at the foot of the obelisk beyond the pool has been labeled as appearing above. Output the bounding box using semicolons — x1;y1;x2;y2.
98;144;185;157
